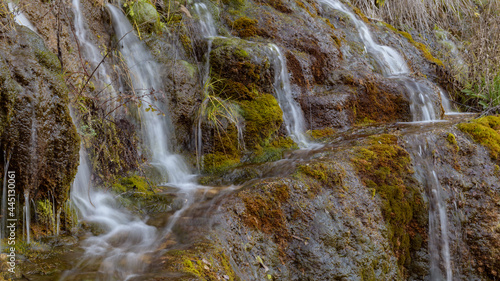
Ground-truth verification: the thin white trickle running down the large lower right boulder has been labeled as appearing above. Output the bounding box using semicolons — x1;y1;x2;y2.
429;171;453;281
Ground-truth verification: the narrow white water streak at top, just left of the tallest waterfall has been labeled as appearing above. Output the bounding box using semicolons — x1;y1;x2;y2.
72;0;117;105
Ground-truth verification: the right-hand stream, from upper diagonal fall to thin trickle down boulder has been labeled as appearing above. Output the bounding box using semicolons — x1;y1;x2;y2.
321;0;452;281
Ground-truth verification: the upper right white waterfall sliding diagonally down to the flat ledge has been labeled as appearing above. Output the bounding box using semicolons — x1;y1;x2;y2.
320;0;446;122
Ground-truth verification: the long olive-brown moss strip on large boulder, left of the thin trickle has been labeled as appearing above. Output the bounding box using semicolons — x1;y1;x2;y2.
352;135;425;267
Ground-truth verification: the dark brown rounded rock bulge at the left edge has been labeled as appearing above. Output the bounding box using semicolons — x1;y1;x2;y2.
0;25;80;205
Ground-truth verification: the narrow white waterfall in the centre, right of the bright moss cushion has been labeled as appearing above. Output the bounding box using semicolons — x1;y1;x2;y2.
270;44;312;148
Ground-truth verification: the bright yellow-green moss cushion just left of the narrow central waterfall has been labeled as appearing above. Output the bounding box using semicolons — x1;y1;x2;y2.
240;94;283;148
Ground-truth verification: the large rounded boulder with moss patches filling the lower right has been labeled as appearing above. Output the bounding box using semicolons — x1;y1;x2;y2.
165;120;500;280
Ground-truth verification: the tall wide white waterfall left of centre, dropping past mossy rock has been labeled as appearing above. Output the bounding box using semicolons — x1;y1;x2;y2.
107;5;195;186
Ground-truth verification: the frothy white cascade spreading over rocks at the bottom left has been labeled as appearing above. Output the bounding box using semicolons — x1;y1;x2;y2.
61;146;158;280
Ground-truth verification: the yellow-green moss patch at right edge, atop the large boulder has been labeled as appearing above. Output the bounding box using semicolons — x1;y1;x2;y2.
457;116;500;160
